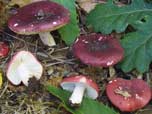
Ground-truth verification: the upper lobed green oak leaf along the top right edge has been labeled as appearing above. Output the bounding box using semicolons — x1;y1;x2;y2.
87;0;152;34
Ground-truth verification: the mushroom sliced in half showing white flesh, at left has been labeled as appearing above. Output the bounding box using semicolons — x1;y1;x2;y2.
6;51;43;86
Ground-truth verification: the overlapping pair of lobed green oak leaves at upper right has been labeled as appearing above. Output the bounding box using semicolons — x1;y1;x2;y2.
87;0;152;73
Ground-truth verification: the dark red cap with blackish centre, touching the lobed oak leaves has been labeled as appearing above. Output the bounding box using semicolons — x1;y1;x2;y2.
73;33;124;67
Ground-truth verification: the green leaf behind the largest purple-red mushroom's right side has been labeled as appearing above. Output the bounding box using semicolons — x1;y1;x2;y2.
53;0;79;45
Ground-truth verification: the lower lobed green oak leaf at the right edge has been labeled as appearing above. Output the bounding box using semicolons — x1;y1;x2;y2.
120;16;152;73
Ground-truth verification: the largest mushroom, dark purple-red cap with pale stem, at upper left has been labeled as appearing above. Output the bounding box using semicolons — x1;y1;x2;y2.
8;1;70;46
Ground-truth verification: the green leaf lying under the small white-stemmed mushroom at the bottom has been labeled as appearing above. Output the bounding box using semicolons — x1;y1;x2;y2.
48;85;118;114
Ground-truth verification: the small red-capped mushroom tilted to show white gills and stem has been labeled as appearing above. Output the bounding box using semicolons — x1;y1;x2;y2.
61;75;99;106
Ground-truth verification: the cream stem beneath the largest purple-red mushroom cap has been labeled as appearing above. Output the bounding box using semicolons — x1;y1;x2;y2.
39;32;56;46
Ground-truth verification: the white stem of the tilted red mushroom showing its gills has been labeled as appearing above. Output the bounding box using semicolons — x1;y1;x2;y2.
69;84;86;104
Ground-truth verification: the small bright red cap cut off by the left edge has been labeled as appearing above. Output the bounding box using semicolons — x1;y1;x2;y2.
0;42;10;58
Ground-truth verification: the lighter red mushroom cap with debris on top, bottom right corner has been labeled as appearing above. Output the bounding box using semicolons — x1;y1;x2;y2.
106;78;151;112
